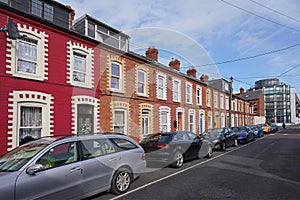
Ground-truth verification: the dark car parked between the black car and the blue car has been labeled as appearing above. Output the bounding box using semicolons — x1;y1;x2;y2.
203;128;237;151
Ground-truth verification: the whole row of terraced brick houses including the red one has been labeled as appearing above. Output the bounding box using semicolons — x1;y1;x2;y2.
0;0;254;154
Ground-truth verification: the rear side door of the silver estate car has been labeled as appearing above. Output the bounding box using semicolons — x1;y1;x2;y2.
81;138;121;194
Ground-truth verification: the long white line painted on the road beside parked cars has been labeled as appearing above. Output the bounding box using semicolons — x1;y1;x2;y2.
111;136;268;200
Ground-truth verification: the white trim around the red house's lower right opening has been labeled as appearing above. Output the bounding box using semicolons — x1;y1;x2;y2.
72;95;100;135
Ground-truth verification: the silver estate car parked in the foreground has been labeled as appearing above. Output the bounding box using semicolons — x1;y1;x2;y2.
0;135;146;199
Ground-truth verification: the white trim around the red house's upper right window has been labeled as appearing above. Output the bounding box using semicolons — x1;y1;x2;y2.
67;41;94;88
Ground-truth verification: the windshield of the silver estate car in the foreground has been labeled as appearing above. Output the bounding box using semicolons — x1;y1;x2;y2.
0;142;47;172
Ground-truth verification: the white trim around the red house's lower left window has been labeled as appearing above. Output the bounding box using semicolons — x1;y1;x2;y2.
7;91;54;151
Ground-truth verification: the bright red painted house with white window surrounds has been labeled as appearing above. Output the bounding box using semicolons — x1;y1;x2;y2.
0;0;100;155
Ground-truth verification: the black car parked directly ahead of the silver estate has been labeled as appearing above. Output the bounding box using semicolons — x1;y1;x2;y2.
141;131;212;168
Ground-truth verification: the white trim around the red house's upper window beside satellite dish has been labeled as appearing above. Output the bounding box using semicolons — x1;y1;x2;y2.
6;24;48;81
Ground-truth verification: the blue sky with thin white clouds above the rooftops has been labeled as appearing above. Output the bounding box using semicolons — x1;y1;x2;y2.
58;0;300;96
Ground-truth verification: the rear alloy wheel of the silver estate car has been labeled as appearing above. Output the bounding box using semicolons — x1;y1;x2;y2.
110;168;132;194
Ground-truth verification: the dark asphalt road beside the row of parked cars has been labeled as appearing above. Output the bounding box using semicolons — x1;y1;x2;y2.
93;129;300;200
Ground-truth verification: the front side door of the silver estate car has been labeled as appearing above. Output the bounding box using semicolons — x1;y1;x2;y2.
16;142;82;199
